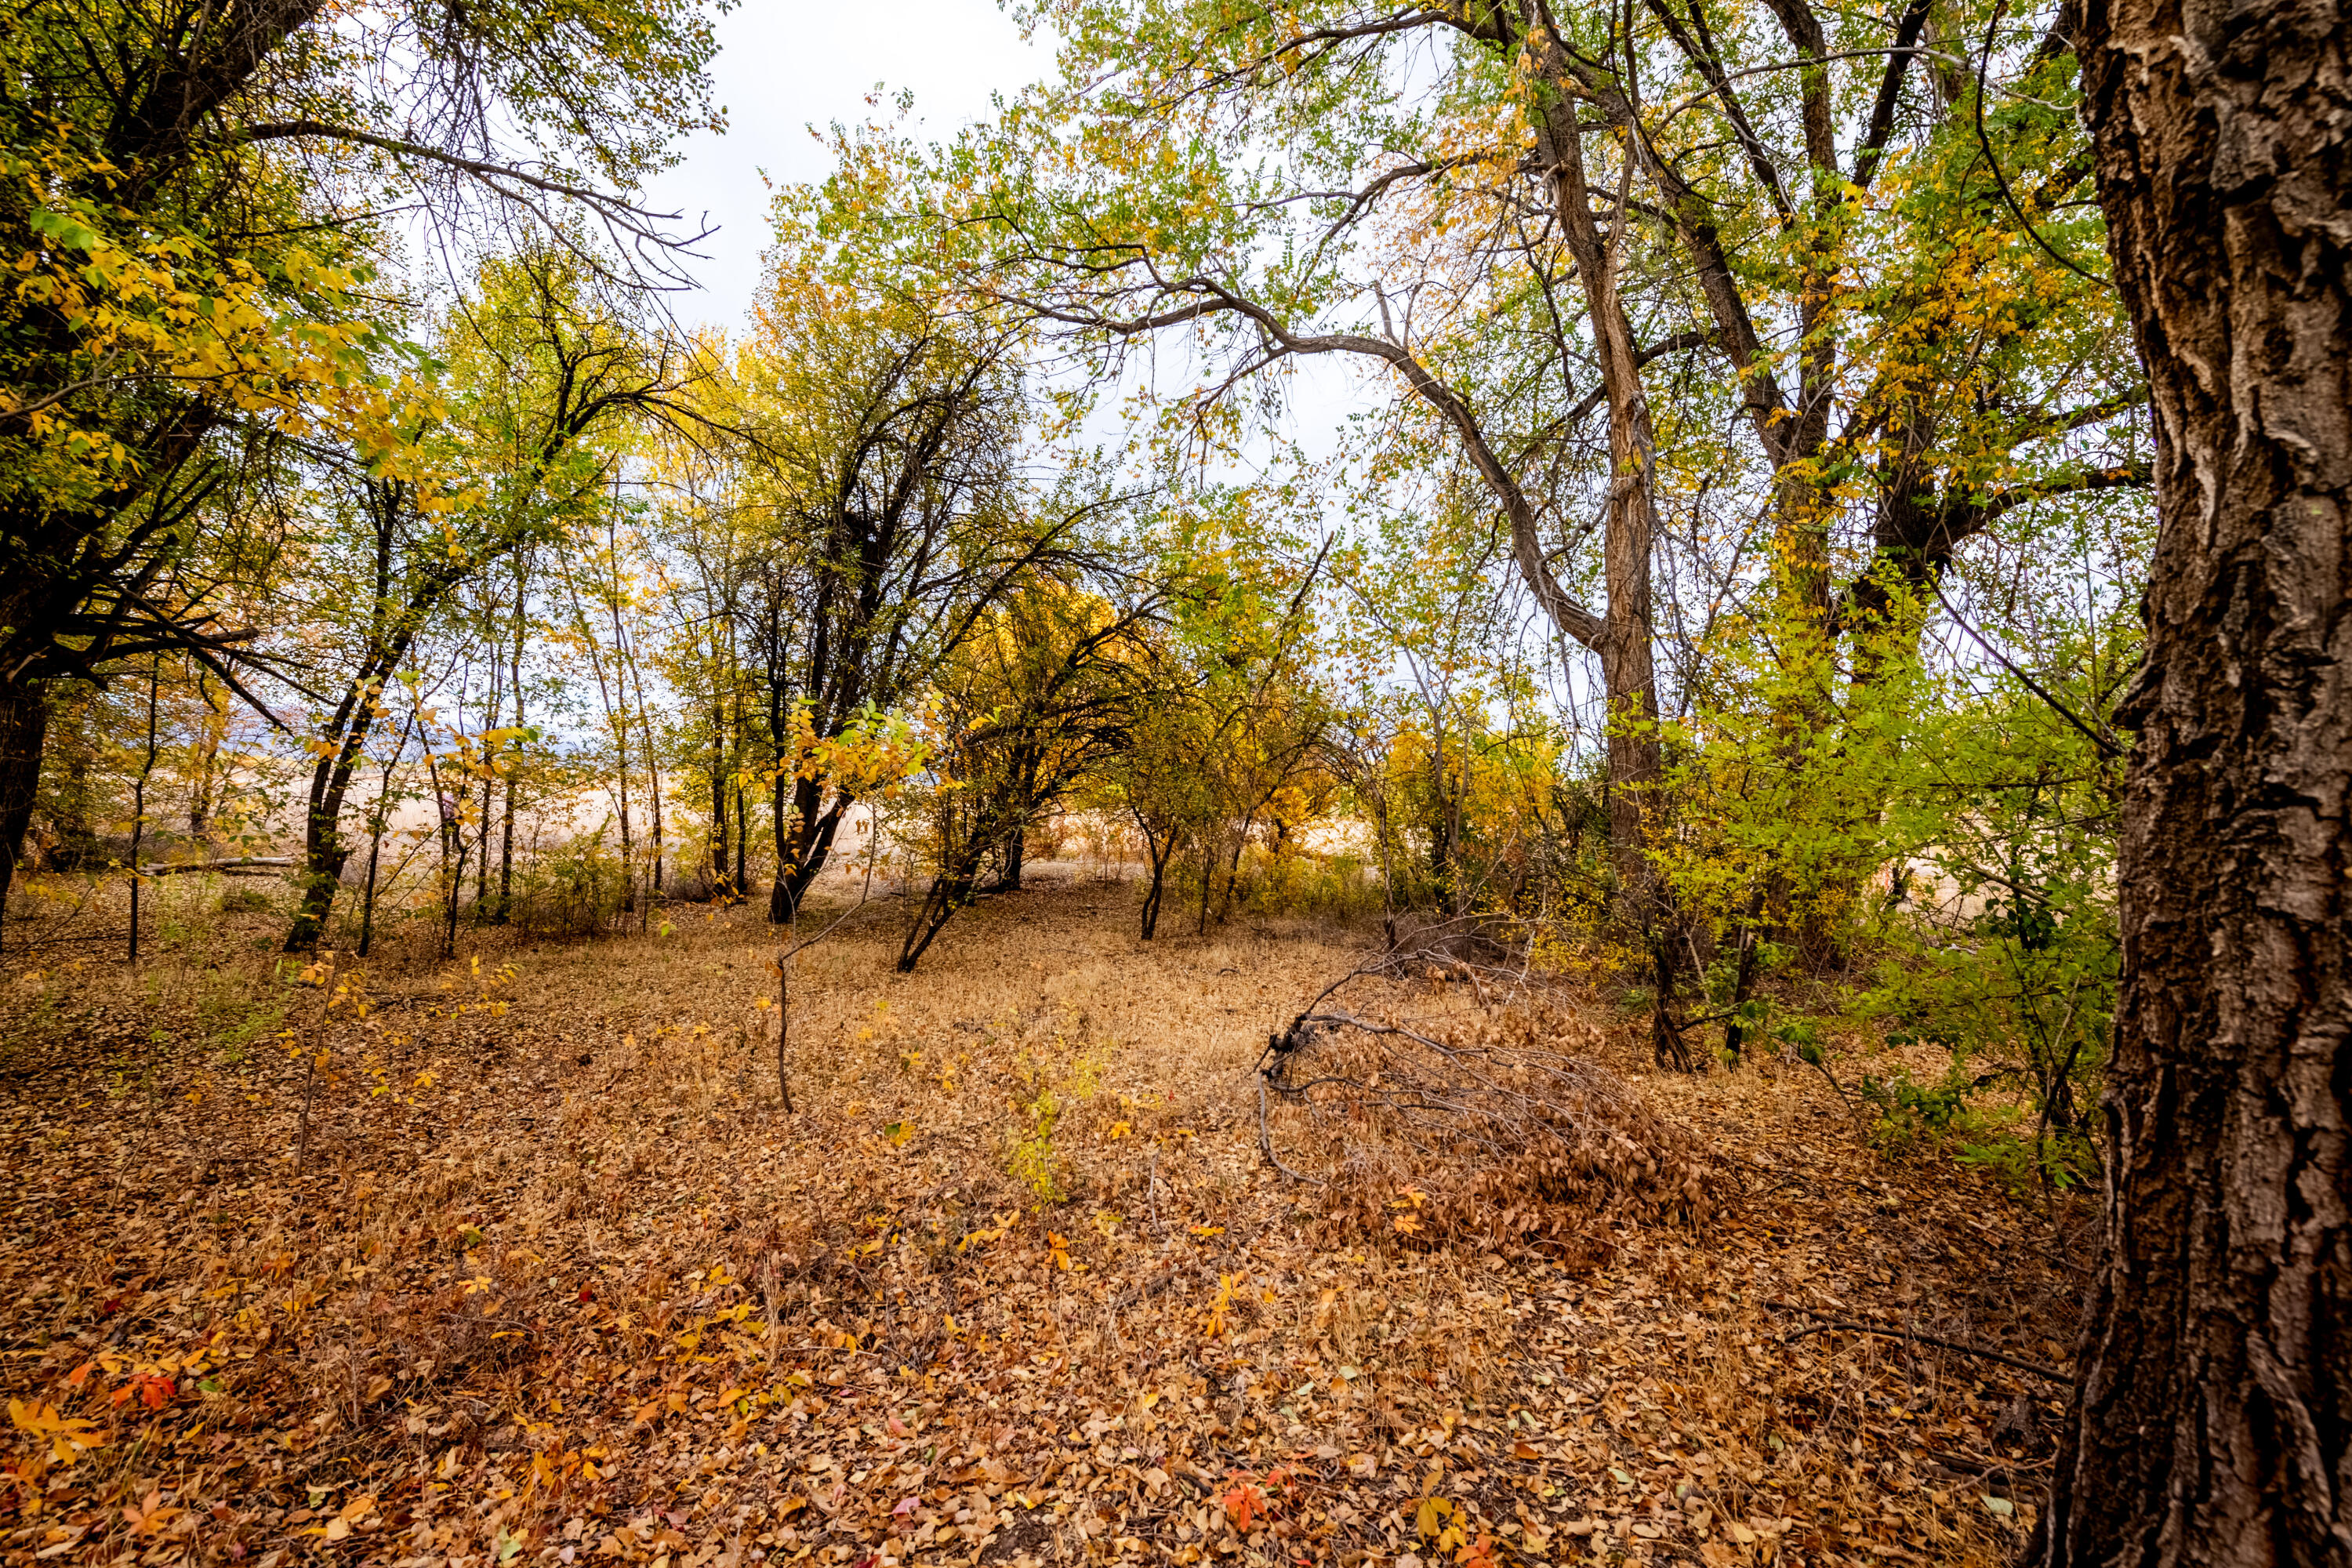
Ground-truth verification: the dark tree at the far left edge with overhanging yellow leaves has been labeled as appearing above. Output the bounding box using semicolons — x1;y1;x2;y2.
0;0;715;931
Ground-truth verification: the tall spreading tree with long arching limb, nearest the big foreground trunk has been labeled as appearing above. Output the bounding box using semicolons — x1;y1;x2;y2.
941;0;2145;945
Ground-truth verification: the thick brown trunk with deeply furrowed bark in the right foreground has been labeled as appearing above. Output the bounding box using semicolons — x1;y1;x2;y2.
2044;0;2352;1566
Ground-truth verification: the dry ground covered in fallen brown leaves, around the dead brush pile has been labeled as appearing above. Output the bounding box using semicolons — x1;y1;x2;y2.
0;881;2077;1568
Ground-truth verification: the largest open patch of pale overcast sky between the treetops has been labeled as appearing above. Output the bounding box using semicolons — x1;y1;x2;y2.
647;0;1054;329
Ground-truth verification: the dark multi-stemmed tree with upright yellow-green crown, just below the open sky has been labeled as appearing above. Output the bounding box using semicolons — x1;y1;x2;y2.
731;187;1101;924
